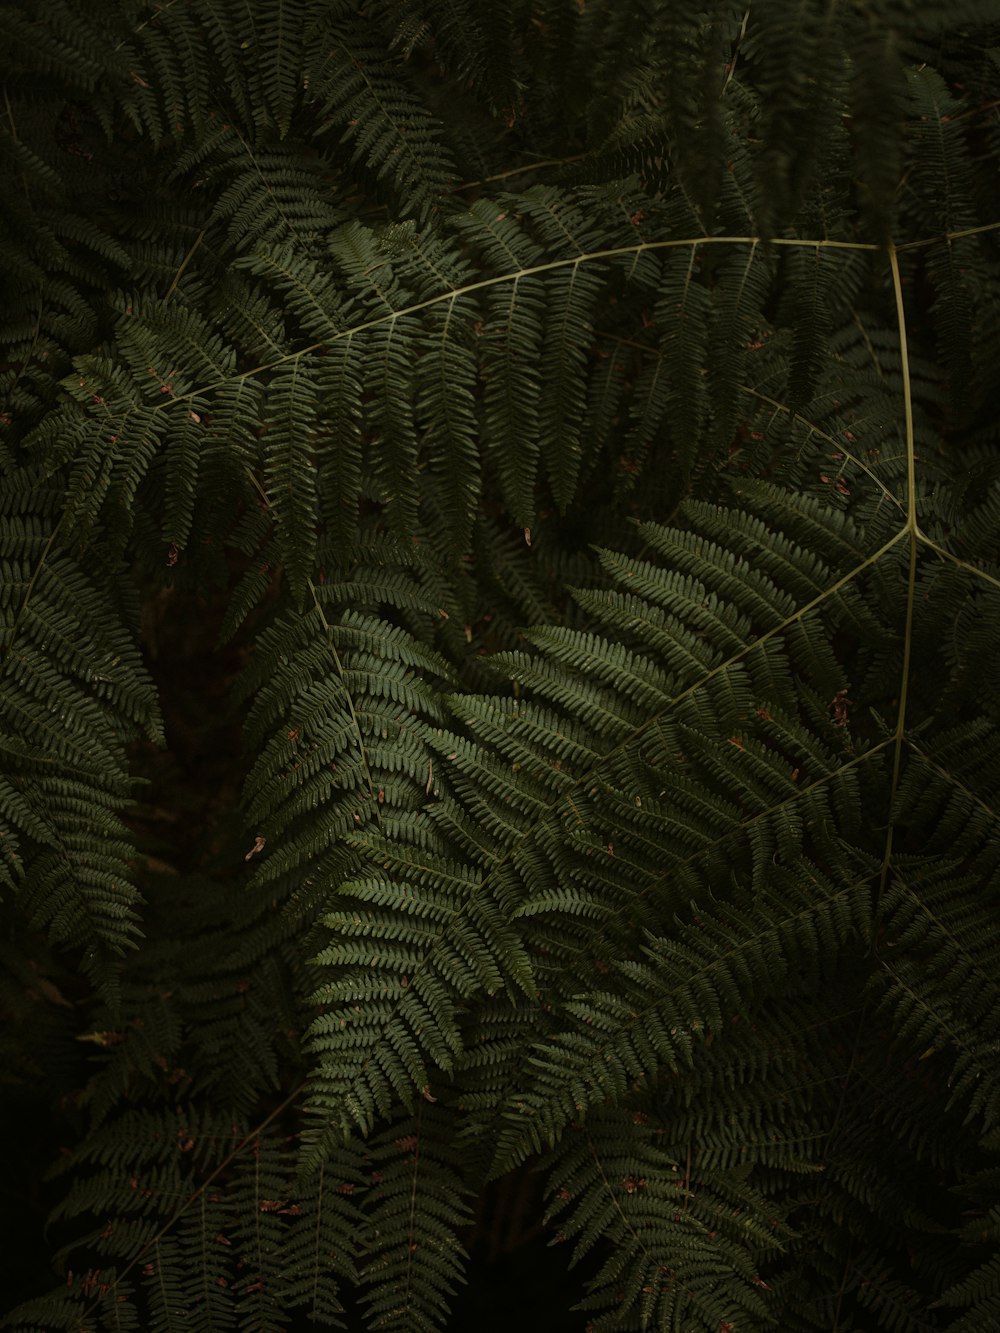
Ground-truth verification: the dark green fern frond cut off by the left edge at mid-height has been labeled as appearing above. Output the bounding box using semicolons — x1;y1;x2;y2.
0;473;163;985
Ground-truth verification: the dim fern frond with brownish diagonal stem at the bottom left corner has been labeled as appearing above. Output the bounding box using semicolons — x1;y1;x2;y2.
37;1104;367;1330
